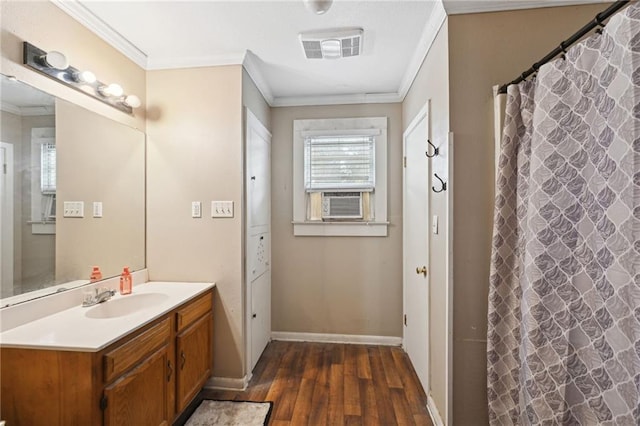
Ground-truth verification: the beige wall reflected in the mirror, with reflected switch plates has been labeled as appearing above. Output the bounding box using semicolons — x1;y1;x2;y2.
55;100;146;283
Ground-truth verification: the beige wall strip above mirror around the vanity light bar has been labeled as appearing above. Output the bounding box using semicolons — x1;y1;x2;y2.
0;0;146;131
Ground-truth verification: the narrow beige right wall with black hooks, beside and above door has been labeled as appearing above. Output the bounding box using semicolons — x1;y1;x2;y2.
402;21;453;424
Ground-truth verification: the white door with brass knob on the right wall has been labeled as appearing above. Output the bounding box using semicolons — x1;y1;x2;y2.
403;106;429;394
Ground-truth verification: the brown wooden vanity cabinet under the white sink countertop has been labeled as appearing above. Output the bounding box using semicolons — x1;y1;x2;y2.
0;290;213;426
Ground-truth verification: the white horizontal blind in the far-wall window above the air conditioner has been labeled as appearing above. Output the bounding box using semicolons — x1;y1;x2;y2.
304;135;375;192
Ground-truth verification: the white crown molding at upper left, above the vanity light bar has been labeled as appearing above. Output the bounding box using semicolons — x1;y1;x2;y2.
50;0;147;69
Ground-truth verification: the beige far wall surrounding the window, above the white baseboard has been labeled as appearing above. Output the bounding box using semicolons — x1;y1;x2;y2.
271;104;402;337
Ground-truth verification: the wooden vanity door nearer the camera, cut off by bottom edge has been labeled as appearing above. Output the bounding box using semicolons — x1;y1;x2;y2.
104;346;172;426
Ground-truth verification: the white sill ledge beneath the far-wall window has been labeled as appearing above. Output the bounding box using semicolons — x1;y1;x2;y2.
291;221;389;237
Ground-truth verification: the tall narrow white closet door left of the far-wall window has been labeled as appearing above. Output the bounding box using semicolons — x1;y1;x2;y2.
245;109;271;371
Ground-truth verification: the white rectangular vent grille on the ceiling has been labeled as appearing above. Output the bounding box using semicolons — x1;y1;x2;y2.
300;28;362;59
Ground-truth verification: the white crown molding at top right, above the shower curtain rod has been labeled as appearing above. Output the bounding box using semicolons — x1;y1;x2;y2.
442;0;610;15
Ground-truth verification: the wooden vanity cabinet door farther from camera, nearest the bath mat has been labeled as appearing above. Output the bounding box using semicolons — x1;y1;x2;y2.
176;314;213;412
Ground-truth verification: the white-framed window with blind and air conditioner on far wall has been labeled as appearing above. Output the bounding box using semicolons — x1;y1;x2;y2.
293;117;388;236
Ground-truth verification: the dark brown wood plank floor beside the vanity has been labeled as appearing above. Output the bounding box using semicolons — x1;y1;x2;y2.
199;341;432;426
